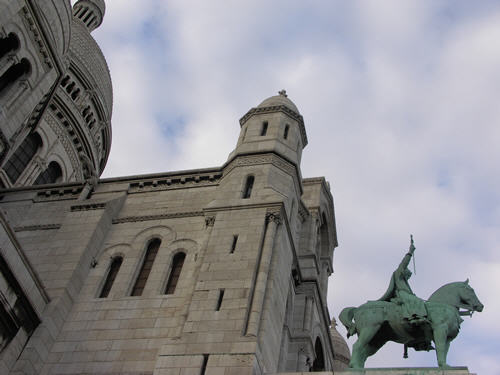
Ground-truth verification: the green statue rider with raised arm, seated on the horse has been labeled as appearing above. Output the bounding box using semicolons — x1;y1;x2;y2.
378;238;427;324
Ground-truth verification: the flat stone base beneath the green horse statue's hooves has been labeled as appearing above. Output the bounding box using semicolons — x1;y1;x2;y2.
334;367;476;375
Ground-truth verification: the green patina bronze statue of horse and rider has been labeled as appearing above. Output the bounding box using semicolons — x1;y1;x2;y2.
339;238;483;368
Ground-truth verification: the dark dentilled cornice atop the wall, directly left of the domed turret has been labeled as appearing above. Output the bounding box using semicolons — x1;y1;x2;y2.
129;172;222;193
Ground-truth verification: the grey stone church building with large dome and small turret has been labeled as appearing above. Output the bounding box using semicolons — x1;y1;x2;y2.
0;0;349;375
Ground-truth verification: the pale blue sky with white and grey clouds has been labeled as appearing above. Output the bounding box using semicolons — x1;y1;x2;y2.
93;0;500;375
